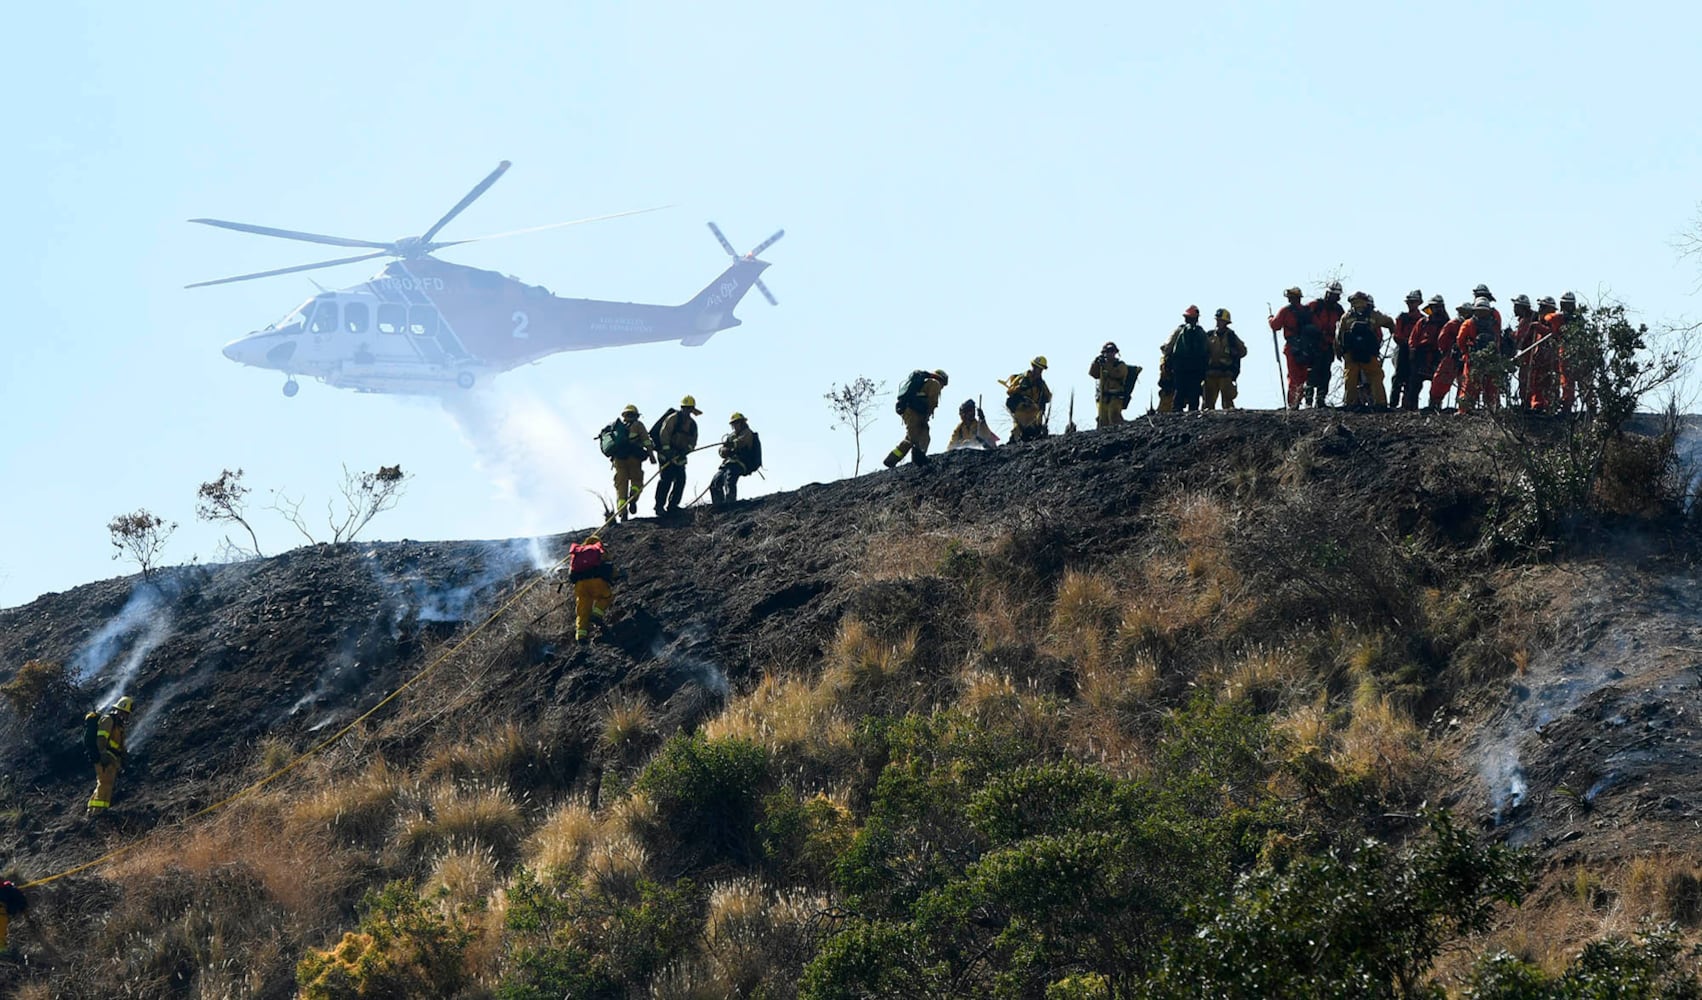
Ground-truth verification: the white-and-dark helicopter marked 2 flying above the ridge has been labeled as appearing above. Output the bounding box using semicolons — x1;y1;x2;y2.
184;160;786;396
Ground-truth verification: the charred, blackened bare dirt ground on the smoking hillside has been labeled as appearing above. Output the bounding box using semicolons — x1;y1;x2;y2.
0;412;1702;904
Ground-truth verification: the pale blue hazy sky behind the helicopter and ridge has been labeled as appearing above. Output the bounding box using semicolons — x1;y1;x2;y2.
0;0;1702;605
